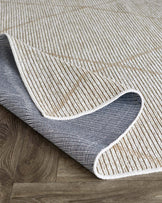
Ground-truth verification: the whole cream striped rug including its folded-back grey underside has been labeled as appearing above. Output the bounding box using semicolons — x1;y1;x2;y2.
0;0;162;179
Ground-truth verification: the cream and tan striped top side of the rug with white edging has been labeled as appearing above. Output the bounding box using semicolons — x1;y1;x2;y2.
0;0;162;179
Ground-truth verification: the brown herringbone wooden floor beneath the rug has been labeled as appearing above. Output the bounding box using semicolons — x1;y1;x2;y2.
0;106;162;203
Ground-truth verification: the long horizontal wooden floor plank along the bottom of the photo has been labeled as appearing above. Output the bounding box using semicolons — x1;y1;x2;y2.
11;180;162;203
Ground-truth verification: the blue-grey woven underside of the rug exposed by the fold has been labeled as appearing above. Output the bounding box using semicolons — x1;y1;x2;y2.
0;35;141;171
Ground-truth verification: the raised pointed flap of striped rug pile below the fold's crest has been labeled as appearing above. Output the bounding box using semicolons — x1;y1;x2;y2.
9;37;128;119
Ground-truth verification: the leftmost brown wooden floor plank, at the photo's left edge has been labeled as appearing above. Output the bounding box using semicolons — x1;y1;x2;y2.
0;106;25;203
